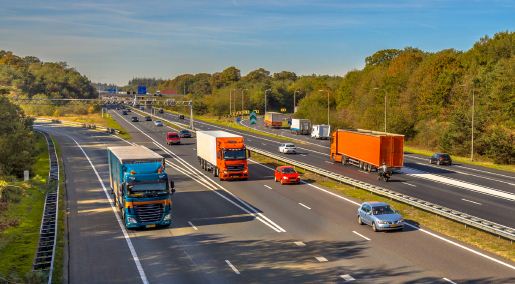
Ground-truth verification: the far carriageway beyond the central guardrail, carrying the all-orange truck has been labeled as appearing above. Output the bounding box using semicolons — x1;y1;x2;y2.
140;108;515;228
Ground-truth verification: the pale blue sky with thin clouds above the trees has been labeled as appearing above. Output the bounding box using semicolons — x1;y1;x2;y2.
0;0;515;85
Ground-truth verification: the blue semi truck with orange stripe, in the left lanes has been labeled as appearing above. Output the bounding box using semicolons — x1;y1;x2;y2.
107;146;175;229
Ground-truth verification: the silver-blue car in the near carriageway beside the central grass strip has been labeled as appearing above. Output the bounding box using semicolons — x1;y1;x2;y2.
358;202;404;232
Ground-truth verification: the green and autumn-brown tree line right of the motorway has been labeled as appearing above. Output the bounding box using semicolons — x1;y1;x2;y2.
128;32;515;164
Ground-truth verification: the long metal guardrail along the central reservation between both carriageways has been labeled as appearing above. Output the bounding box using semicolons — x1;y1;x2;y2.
247;146;515;241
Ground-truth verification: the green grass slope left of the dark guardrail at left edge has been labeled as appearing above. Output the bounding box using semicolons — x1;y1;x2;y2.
0;134;49;282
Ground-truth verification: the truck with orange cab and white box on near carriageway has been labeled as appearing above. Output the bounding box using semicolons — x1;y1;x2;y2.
196;130;250;180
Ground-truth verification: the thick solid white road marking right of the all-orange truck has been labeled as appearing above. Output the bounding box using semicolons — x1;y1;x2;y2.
402;168;515;201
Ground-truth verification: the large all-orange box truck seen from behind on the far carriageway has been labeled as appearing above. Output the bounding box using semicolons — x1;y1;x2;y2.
330;129;404;172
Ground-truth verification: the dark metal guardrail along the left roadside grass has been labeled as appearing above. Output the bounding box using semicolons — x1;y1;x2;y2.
32;131;59;283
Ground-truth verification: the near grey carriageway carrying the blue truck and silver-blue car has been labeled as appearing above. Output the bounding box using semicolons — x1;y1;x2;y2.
34;108;515;283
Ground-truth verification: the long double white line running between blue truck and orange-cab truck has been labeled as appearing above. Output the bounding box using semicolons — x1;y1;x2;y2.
117;111;286;233
